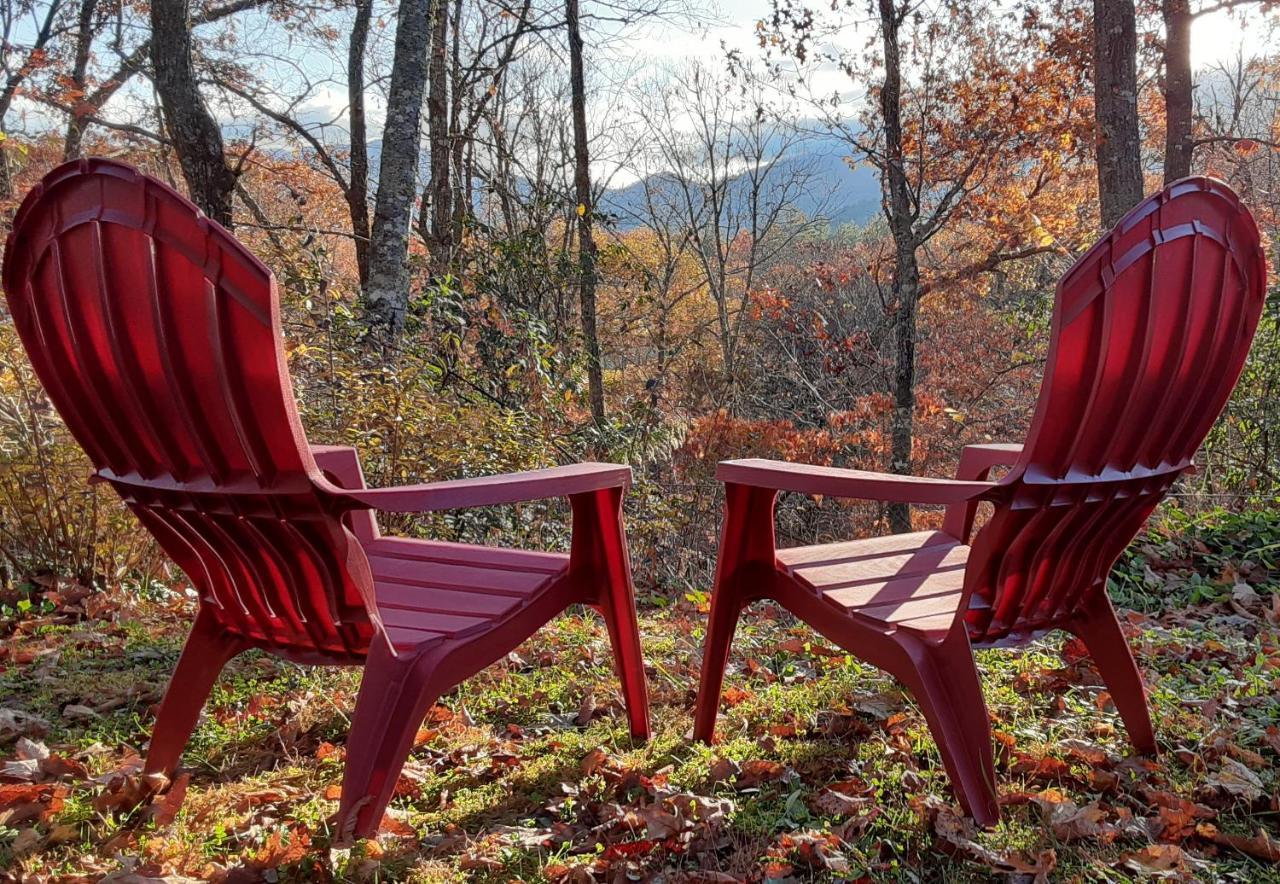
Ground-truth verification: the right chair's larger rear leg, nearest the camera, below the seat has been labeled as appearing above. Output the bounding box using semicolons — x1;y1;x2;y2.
902;627;1000;826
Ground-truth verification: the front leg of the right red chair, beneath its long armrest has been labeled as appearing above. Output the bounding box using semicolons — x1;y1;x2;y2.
694;484;778;743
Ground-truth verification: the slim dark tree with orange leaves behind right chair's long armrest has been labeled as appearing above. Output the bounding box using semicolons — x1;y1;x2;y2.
760;0;1089;531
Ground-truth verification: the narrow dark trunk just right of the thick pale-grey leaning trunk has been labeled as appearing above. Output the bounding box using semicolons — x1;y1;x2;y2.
420;0;457;276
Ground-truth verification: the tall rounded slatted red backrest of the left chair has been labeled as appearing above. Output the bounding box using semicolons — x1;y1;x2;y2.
4;159;376;659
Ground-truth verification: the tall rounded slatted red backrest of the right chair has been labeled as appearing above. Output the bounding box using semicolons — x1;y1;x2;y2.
966;178;1266;643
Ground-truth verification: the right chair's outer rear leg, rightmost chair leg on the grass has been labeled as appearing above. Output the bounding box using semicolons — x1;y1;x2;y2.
1066;592;1158;755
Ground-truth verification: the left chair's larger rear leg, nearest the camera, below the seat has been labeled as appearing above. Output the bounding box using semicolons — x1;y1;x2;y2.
334;637;442;846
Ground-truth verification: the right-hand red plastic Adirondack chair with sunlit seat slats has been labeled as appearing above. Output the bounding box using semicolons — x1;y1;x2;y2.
694;178;1266;825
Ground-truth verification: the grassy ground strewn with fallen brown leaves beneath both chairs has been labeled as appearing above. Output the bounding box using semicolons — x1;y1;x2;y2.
0;563;1280;884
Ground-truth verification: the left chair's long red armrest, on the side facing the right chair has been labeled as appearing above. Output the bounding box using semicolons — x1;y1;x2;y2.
326;463;631;513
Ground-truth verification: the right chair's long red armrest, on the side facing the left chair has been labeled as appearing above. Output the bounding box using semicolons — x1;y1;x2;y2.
716;459;996;504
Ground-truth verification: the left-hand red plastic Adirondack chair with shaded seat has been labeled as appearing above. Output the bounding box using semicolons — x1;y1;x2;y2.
4;160;649;839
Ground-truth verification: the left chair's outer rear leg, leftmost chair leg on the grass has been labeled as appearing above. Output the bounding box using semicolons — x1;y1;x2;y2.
145;608;244;777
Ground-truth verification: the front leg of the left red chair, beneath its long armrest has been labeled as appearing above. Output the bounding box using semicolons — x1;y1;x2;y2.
570;487;650;739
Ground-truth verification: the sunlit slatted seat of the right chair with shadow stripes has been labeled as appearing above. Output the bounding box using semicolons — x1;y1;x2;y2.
777;531;969;633
